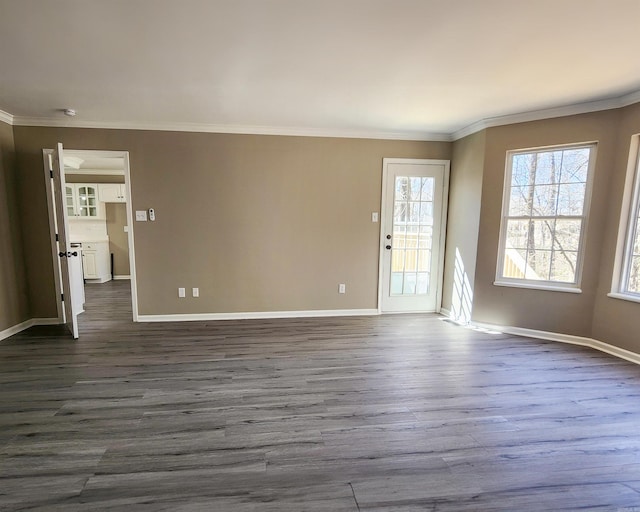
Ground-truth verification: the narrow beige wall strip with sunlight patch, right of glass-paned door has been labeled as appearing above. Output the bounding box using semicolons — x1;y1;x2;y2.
442;131;486;322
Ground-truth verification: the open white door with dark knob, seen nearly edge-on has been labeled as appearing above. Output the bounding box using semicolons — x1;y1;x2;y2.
49;143;81;339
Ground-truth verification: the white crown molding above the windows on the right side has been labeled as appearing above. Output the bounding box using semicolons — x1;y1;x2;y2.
451;91;640;141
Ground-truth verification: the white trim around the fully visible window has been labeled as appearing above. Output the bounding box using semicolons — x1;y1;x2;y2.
493;141;598;293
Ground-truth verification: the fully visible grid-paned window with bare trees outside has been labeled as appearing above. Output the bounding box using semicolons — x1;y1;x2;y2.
496;144;595;292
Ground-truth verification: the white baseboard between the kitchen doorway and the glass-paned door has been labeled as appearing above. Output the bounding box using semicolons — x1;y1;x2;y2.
138;309;379;322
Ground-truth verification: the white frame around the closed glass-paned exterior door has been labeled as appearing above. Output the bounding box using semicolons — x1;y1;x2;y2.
378;158;451;315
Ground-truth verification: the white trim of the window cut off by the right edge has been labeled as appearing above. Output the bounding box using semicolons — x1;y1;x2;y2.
607;134;640;302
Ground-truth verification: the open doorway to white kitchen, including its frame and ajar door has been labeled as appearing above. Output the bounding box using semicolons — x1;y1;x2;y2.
43;145;138;337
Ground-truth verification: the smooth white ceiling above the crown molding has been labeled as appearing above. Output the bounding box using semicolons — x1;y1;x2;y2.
0;0;640;139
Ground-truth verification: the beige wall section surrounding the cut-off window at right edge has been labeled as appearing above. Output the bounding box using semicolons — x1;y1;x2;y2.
593;104;640;353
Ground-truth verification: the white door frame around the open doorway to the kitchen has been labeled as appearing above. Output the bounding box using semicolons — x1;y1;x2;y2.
42;148;138;323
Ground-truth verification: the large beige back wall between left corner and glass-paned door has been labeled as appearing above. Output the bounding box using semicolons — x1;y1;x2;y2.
14;127;451;316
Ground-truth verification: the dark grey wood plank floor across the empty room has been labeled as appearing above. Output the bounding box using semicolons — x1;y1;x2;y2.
0;281;640;512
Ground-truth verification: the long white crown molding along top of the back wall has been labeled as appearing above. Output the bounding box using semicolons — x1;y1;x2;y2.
13;116;451;142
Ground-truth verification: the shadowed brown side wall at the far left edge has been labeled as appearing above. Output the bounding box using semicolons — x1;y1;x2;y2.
0;122;29;331
